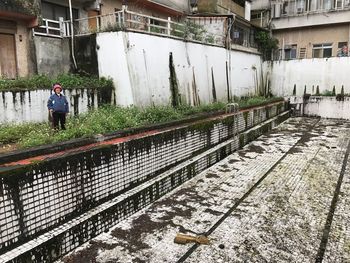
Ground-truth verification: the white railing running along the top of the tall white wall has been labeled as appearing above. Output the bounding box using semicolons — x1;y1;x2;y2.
33;10;226;46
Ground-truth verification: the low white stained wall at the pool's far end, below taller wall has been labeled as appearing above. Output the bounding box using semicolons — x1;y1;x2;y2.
290;96;350;120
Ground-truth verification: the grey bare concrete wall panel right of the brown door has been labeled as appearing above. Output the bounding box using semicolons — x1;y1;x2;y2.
34;36;71;76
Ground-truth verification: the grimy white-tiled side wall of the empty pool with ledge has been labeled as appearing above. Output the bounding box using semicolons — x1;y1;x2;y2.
0;102;288;262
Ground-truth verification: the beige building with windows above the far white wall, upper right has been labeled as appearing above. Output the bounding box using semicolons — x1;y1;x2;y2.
271;0;350;59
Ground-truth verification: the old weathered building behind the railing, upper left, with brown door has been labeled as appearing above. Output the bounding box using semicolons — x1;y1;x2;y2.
0;0;190;79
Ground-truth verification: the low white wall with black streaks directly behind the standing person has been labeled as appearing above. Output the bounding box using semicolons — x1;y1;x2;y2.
0;89;98;124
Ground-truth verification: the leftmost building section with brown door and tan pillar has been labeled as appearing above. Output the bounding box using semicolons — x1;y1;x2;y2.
0;0;39;79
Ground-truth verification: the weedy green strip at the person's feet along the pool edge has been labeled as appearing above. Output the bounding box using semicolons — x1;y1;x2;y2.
0;97;280;151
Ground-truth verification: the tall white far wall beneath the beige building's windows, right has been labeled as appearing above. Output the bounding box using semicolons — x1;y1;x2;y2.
263;57;350;96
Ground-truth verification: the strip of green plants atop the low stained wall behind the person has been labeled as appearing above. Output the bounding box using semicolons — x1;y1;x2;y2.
0;74;113;91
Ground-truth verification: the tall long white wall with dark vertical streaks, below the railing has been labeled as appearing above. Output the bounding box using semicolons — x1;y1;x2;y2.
97;32;262;106
